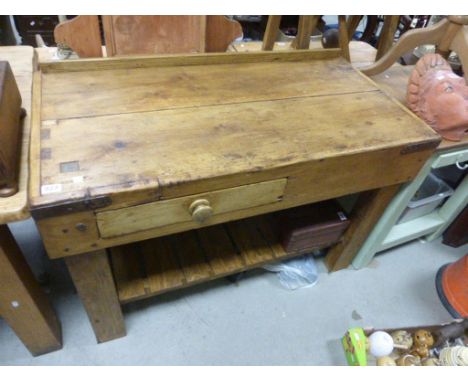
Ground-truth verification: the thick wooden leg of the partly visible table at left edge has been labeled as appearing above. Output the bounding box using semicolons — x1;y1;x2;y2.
0;225;62;356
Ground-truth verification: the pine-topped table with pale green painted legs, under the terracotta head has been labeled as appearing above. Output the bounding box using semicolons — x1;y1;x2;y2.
233;41;468;269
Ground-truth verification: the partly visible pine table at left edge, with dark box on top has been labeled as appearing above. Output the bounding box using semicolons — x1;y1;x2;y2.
0;46;62;355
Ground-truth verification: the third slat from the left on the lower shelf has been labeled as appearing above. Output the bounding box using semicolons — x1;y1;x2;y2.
171;231;212;283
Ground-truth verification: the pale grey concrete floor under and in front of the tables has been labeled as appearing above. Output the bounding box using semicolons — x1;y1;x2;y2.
0;221;468;365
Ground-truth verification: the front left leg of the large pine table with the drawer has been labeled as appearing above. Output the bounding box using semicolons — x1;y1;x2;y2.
65;250;126;343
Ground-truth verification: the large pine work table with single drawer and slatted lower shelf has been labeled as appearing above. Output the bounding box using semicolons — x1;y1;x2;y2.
29;49;440;342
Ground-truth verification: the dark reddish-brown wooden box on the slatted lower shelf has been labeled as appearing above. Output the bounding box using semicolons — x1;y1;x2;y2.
278;200;349;254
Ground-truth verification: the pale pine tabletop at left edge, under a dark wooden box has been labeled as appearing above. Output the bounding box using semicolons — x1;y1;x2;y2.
0;46;34;224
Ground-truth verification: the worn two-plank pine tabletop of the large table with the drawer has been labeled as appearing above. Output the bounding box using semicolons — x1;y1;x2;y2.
31;51;437;212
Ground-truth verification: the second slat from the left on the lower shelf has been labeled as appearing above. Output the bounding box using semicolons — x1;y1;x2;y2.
140;237;186;294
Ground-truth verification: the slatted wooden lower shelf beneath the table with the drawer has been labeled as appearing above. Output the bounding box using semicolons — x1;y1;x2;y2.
110;215;300;304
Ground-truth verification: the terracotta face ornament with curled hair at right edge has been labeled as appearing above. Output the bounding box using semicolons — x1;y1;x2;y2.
406;53;468;141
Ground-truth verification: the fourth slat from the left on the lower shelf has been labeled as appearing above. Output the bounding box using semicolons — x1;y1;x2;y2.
196;224;246;277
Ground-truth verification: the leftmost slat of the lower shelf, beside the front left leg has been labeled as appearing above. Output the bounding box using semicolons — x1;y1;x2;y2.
110;244;149;301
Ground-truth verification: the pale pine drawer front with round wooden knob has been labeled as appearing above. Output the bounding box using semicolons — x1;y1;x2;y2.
96;178;287;238
